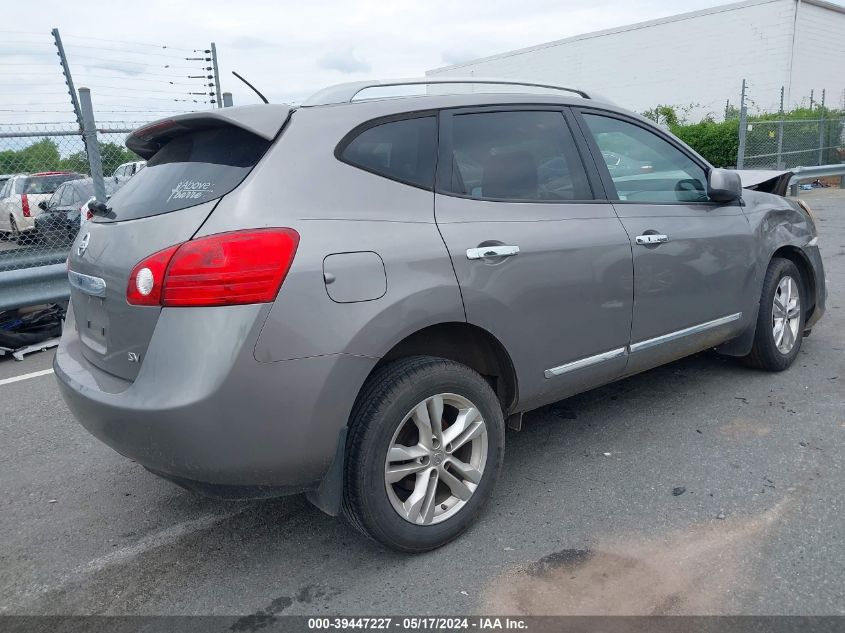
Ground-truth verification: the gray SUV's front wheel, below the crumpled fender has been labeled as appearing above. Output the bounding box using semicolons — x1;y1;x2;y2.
743;257;807;371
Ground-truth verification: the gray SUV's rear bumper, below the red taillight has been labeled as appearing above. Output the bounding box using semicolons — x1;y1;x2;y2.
54;306;377;497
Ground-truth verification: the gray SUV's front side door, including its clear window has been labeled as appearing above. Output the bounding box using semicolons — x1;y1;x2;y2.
578;108;756;373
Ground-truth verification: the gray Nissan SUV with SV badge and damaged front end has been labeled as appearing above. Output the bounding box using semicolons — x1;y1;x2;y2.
55;79;826;552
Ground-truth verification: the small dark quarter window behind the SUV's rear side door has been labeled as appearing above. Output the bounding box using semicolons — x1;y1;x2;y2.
342;116;437;189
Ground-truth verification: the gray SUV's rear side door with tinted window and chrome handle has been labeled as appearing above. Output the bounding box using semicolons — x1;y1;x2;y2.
435;107;633;409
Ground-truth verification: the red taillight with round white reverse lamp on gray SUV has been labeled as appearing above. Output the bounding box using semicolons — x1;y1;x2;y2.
126;229;299;307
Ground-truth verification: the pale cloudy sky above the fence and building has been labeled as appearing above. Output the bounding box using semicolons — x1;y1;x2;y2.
0;0;836;125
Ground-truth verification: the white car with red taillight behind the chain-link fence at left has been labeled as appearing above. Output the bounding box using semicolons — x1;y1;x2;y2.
0;171;85;244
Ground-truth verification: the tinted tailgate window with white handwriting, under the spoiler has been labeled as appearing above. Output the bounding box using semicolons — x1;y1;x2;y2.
101;126;270;222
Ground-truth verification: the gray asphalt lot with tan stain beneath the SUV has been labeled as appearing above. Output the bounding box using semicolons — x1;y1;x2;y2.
0;190;845;623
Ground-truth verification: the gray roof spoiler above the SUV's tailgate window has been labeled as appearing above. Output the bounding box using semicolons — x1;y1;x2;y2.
126;104;293;160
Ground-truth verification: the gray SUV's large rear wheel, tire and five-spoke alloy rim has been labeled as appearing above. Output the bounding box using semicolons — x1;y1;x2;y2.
343;356;505;553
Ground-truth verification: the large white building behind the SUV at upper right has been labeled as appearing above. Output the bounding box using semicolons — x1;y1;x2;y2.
426;0;845;122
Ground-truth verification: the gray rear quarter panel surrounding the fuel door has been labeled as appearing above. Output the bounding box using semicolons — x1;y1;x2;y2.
198;103;465;362
